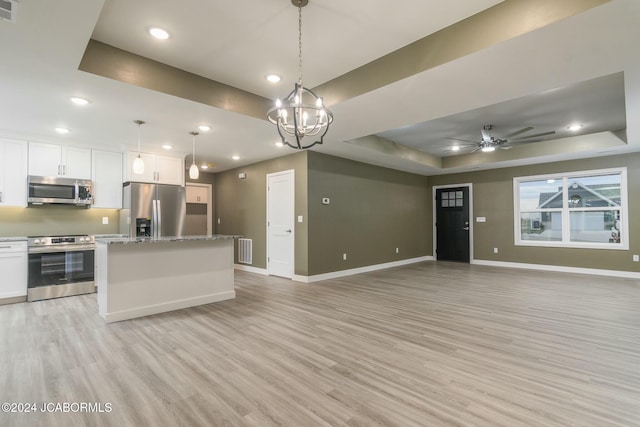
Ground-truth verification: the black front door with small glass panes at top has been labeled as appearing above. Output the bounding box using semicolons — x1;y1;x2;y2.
436;187;469;262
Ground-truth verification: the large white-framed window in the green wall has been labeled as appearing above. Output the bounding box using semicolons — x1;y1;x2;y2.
513;168;629;249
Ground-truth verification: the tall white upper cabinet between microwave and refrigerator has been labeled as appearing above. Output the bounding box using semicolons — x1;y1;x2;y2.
91;150;122;209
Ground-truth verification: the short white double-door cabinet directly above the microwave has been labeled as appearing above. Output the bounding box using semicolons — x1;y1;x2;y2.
29;142;91;179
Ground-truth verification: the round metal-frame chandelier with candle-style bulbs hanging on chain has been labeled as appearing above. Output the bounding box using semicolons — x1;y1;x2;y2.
267;0;333;150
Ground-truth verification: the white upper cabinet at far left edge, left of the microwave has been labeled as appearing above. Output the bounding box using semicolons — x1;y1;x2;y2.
0;138;27;207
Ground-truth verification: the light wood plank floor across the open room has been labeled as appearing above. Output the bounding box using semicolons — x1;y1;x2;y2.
0;262;640;427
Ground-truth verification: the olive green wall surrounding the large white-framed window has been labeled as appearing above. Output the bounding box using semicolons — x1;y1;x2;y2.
429;153;640;271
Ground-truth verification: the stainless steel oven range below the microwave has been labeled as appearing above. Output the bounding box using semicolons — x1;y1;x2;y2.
27;235;95;301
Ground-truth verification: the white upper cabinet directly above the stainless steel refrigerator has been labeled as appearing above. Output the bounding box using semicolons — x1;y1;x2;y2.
124;151;184;186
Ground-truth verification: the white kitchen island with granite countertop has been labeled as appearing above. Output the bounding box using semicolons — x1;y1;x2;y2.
95;235;240;323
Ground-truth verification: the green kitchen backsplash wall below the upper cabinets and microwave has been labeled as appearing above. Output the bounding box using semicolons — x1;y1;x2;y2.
0;206;119;237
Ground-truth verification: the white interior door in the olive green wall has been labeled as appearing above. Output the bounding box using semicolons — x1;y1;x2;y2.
267;170;295;279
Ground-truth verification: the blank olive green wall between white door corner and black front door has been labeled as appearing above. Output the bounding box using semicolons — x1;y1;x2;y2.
308;152;432;275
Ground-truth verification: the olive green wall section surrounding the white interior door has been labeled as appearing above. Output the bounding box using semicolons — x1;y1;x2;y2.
214;151;308;275
